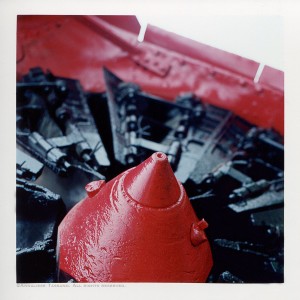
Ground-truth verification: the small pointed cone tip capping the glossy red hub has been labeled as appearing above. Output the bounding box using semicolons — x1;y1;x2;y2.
124;152;181;208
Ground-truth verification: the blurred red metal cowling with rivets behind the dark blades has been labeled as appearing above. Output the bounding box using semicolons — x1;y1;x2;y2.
17;16;284;134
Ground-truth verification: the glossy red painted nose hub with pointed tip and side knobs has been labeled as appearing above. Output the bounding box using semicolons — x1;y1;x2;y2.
58;152;212;282
